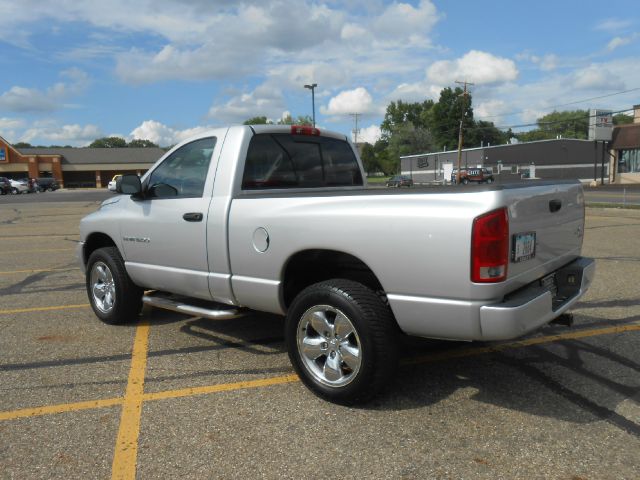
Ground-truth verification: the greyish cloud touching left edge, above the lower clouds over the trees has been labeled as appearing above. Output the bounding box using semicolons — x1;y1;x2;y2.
0;68;89;112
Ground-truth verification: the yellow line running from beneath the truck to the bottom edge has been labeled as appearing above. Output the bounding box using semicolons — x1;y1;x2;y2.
111;320;149;479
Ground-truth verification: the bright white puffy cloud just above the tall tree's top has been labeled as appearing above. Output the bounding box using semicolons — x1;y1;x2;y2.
427;50;518;85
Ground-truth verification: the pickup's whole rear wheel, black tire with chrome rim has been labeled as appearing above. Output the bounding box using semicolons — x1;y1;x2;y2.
285;279;399;405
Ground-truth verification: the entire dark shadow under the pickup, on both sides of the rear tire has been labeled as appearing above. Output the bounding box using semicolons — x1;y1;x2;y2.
150;313;640;437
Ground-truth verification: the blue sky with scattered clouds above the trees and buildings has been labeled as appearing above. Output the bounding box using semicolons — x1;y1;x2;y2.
0;0;640;146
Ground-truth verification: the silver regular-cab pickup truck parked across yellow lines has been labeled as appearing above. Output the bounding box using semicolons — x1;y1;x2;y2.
77;126;595;403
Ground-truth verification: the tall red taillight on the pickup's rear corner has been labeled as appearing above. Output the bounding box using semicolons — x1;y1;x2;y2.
471;208;509;283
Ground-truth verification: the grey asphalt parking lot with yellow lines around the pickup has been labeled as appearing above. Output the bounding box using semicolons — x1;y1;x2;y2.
0;192;640;480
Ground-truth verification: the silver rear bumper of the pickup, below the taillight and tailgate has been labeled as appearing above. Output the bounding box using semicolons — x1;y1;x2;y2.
480;258;595;340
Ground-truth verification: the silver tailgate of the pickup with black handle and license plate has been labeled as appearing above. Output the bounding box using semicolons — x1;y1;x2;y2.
504;183;584;288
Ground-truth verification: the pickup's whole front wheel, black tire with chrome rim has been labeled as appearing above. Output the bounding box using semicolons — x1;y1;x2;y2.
86;247;143;325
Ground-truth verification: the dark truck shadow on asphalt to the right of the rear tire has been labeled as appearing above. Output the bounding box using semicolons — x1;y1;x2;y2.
372;316;640;437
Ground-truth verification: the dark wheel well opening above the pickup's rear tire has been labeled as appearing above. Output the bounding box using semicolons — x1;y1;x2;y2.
281;249;384;309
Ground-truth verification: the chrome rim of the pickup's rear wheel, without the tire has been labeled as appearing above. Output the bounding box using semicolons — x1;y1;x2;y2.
297;305;362;387
